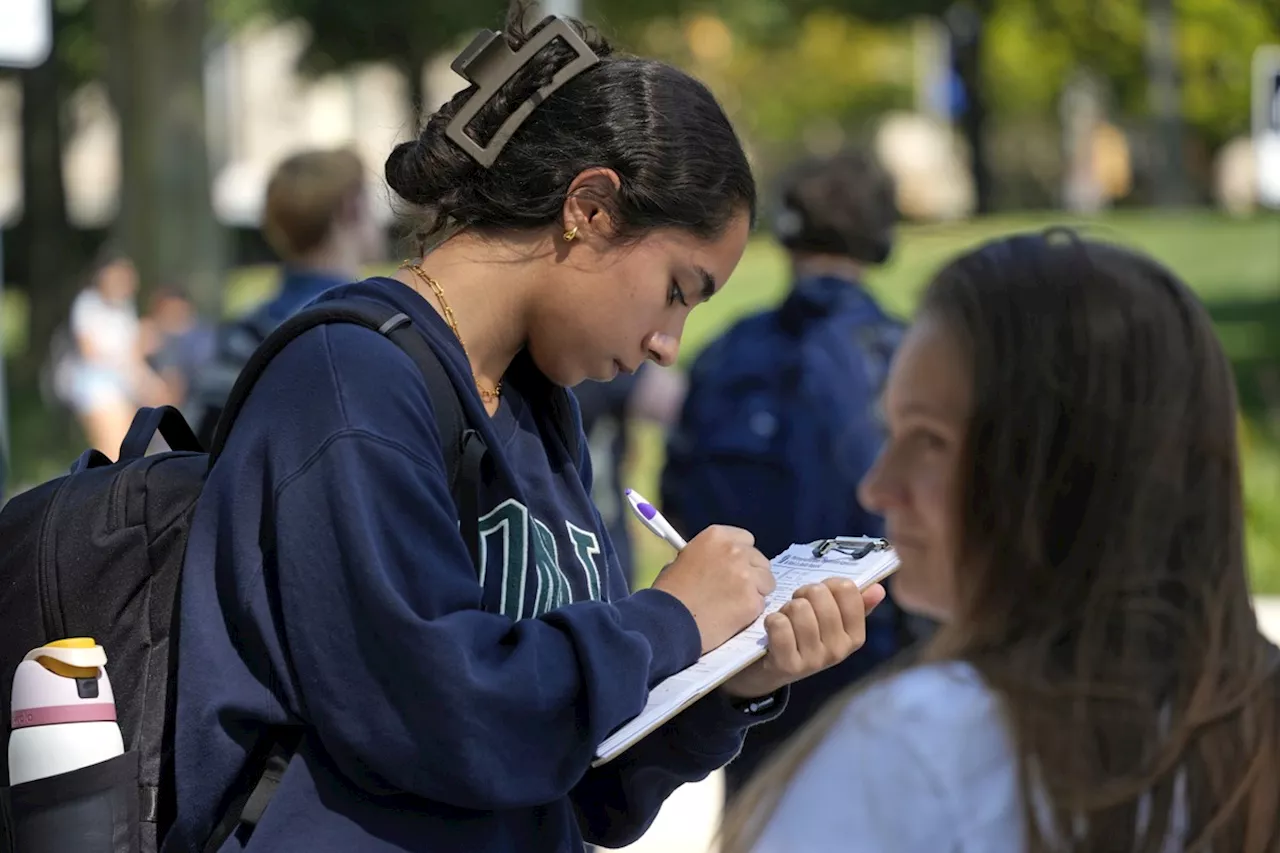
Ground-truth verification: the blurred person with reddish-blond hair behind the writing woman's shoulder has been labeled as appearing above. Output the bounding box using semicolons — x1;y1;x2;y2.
191;149;385;447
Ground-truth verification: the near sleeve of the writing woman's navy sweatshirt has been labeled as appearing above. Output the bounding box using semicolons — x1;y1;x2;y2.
267;403;699;809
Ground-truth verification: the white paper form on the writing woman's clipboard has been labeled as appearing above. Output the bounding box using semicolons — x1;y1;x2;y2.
593;543;899;767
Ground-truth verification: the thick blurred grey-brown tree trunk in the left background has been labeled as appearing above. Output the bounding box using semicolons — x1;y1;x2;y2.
97;0;223;316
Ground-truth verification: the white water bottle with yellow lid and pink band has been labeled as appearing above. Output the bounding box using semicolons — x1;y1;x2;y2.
9;637;124;785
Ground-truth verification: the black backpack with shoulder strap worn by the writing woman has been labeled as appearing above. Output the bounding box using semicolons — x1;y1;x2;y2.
0;297;579;853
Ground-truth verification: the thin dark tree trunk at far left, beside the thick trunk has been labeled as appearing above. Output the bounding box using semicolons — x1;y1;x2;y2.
14;44;79;387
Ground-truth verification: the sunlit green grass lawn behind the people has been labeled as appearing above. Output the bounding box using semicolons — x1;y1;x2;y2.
3;211;1280;594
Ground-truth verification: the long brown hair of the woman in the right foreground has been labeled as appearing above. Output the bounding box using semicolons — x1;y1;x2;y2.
722;229;1280;853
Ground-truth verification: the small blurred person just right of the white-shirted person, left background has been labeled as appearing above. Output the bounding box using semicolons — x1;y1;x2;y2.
142;287;218;409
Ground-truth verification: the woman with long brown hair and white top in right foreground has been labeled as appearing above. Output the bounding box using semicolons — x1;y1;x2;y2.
723;231;1280;853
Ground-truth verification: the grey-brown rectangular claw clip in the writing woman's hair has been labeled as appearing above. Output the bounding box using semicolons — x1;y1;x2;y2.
444;18;600;168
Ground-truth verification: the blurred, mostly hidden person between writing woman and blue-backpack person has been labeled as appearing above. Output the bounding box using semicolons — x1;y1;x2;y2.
573;361;687;588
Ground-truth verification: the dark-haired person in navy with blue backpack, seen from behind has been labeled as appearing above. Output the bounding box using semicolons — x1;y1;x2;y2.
662;151;914;794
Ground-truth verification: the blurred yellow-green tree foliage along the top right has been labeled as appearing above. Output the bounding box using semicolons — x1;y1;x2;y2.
596;0;1280;201
